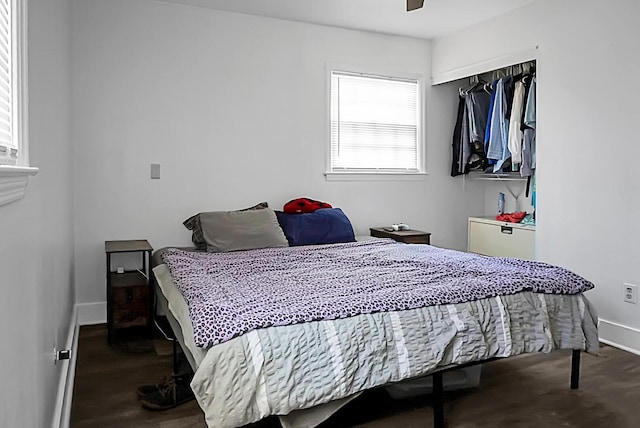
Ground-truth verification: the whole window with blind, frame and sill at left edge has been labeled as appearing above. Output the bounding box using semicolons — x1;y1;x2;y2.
0;0;38;205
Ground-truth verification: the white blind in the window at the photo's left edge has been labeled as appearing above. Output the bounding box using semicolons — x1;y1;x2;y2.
0;0;18;165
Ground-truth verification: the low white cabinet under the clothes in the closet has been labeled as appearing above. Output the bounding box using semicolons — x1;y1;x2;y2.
467;217;536;260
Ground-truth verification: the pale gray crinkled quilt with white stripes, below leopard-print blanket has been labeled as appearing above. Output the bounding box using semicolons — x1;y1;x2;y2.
154;249;598;428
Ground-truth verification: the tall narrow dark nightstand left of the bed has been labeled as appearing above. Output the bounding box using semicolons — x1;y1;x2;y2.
104;239;153;343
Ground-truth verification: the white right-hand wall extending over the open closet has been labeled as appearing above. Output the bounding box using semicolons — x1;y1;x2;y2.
433;0;640;352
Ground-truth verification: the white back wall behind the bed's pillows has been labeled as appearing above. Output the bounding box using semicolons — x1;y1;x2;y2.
72;0;482;303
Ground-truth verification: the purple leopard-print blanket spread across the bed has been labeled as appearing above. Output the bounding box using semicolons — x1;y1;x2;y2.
162;239;593;347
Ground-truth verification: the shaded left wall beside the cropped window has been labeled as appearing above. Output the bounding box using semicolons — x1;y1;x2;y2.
0;0;75;427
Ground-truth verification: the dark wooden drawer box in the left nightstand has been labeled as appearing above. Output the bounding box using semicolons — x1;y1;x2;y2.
113;284;149;328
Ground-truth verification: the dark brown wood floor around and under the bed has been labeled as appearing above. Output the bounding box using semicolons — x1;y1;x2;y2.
71;325;640;428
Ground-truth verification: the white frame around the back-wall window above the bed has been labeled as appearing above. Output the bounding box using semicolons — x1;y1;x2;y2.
324;63;428;181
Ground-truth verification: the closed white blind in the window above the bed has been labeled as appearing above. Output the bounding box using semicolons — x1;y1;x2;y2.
330;71;422;173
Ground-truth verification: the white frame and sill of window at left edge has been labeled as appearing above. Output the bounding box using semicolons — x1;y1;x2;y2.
0;0;39;206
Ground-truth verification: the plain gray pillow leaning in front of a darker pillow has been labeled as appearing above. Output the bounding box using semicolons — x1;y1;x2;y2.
200;208;289;252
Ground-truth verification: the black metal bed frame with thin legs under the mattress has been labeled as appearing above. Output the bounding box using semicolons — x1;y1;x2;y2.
151;271;582;428
